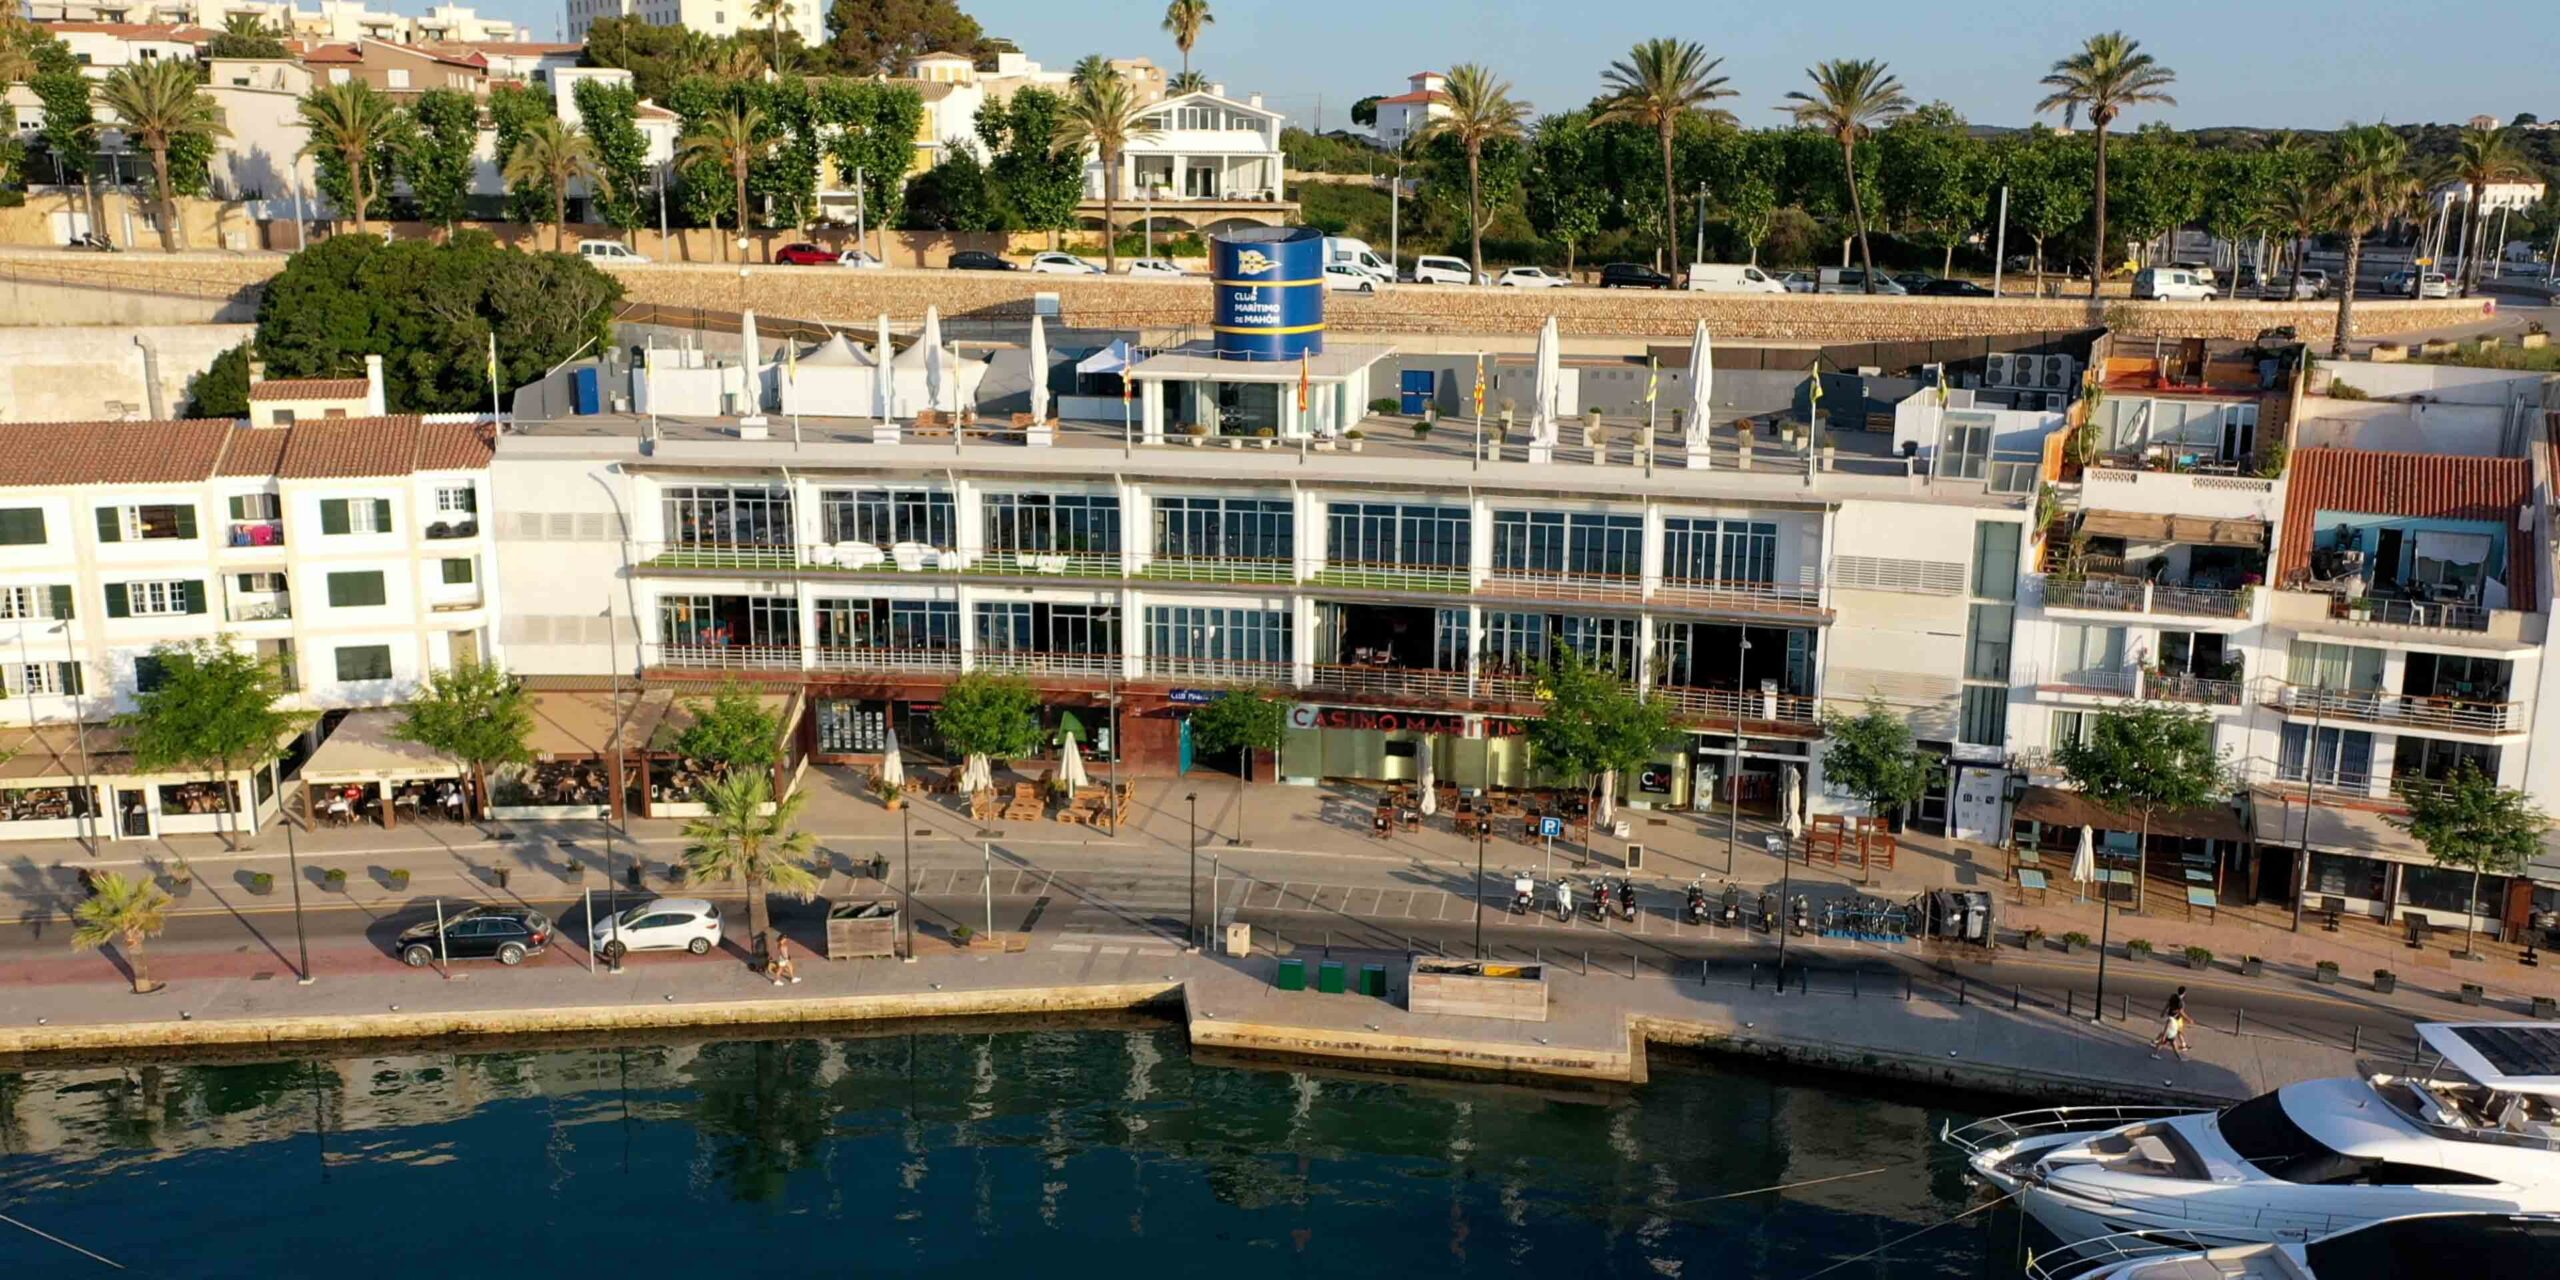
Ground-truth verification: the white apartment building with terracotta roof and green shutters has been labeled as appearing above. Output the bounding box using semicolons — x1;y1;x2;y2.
0;381;497;837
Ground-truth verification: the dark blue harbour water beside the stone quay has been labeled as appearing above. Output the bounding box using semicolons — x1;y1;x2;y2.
0;1024;2017;1280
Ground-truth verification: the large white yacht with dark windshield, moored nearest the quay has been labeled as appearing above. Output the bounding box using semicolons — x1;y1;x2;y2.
1943;1021;2560;1247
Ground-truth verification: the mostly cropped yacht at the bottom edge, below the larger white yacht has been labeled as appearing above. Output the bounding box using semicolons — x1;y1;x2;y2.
2028;1213;2560;1280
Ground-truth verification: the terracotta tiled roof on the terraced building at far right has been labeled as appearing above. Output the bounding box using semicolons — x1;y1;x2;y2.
2276;448;2540;612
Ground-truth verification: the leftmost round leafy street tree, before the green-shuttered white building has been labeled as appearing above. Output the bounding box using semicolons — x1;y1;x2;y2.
115;635;310;847
